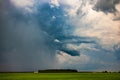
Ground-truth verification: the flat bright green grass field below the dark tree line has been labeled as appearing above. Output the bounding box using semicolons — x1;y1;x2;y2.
0;73;120;80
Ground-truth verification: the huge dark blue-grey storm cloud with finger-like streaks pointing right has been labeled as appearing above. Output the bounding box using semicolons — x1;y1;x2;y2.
0;0;92;71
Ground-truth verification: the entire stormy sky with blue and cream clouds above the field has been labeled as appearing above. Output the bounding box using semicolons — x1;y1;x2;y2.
0;0;120;71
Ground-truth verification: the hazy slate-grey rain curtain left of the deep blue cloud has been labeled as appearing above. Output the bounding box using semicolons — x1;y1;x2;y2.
0;0;58;71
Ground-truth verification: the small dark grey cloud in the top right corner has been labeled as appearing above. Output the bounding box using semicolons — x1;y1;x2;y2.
93;0;120;13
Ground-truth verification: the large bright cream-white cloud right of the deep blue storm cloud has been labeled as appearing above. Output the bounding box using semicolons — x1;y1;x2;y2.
64;1;120;50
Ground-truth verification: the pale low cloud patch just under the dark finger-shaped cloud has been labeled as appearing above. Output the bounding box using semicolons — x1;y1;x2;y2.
57;52;90;66
